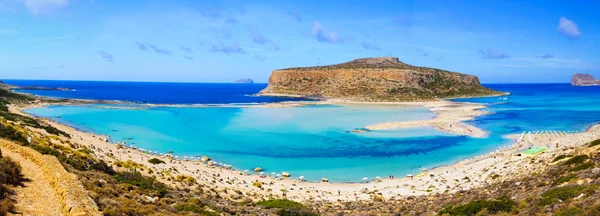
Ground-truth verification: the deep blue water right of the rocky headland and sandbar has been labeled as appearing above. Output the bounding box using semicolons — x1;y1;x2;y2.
455;83;600;134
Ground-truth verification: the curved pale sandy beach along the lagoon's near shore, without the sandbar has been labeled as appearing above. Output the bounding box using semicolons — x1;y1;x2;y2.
10;98;600;201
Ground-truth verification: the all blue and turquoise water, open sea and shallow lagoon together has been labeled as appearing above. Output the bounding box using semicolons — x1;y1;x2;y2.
4;80;600;182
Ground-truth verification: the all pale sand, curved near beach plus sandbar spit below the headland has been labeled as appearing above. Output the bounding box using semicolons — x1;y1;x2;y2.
9;101;600;201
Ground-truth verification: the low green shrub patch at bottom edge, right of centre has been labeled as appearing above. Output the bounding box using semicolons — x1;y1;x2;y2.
438;197;517;215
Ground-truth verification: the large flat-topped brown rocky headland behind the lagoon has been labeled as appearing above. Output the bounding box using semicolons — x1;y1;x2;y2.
259;57;500;101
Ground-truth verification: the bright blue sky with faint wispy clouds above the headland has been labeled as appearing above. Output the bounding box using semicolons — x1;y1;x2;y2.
0;0;600;83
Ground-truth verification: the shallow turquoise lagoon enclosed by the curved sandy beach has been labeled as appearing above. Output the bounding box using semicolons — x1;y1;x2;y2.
27;105;508;182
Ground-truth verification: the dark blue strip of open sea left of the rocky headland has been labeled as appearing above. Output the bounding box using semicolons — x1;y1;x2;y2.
3;80;306;104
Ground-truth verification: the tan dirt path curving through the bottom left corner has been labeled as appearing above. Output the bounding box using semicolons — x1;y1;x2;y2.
0;145;64;215
